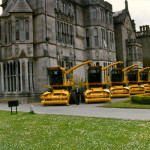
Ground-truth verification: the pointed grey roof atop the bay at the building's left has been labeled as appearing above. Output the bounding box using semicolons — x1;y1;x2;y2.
10;0;33;13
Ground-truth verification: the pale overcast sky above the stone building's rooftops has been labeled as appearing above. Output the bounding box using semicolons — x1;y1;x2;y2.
0;0;150;31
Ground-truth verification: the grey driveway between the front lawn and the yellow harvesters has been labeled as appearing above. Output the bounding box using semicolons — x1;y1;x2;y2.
0;99;150;121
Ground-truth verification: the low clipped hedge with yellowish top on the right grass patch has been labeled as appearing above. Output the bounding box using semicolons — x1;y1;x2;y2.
131;94;150;104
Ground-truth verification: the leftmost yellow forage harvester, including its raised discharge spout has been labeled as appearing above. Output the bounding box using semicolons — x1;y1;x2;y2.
41;60;93;106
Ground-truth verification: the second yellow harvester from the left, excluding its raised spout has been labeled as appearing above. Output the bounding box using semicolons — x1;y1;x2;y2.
81;66;111;104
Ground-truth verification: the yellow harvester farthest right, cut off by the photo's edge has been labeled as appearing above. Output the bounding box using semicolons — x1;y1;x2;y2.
138;67;150;93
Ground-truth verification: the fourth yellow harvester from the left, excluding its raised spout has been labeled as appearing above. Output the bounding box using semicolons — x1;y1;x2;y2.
127;65;145;95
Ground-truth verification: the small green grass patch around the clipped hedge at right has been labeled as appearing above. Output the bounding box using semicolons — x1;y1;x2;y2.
103;99;150;109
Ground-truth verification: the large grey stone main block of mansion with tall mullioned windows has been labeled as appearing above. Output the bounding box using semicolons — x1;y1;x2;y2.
0;0;116;100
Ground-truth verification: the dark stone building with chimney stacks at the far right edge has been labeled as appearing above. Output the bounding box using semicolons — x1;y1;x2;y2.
136;25;150;68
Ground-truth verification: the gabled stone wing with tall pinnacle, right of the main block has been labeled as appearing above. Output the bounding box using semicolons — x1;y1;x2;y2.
113;0;143;68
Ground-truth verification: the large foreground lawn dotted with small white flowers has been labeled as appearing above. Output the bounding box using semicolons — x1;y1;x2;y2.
0;111;150;150
